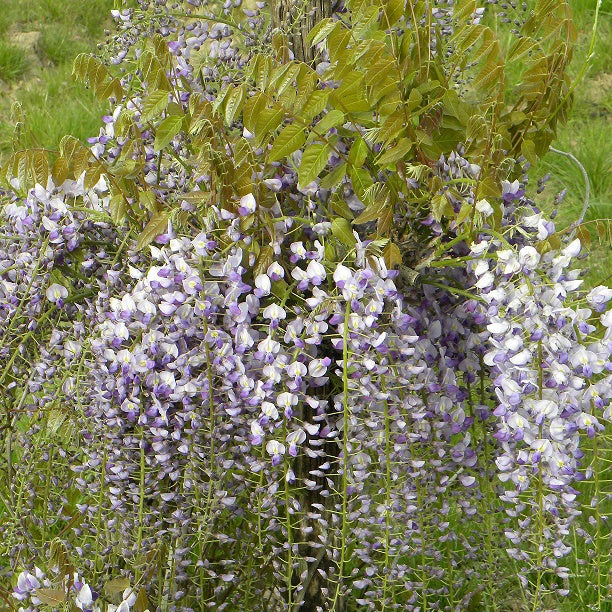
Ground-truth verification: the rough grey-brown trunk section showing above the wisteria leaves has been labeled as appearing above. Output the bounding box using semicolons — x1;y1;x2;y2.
271;0;334;64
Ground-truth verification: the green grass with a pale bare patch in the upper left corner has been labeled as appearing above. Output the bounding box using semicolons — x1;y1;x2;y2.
0;0;113;156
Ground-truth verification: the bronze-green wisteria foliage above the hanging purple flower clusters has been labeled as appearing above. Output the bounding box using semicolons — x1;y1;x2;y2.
4;0;575;265
